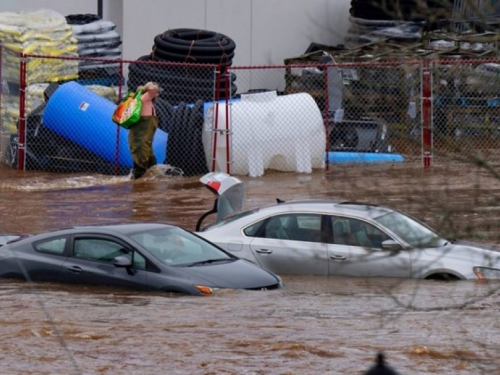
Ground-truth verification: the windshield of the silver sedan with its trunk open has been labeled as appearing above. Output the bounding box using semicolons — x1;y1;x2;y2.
375;211;447;247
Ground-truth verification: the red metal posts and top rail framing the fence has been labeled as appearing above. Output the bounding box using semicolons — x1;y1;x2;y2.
0;47;500;174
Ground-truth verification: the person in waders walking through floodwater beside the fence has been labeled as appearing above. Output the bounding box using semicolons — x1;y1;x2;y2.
128;82;160;180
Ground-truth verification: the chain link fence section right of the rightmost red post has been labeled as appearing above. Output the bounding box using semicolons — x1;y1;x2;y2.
432;59;500;164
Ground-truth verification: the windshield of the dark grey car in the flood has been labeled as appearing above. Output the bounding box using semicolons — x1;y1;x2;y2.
128;227;232;266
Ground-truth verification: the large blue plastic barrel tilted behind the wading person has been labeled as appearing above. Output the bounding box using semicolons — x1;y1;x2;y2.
43;82;168;168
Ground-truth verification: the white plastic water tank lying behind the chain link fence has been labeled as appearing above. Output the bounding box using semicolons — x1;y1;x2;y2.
202;91;326;177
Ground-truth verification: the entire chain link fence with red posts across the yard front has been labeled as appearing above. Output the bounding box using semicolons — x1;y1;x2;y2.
0;47;500;177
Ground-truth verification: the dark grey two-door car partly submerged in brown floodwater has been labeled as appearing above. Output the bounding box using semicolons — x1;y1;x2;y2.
0;223;281;295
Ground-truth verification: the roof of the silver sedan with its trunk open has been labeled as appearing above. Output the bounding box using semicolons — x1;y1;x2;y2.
254;199;395;218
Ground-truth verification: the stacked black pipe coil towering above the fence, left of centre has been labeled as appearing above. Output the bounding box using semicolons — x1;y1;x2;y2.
129;29;237;105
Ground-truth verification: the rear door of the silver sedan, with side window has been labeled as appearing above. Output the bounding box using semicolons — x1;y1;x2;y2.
250;213;328;275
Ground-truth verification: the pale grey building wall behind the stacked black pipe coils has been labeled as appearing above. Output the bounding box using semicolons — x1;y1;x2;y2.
0;0;351;66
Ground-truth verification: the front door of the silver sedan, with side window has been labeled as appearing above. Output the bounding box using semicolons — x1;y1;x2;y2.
328;216;411;277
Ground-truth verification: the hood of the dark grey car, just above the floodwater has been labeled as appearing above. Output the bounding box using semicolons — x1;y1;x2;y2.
182;259;280;289
